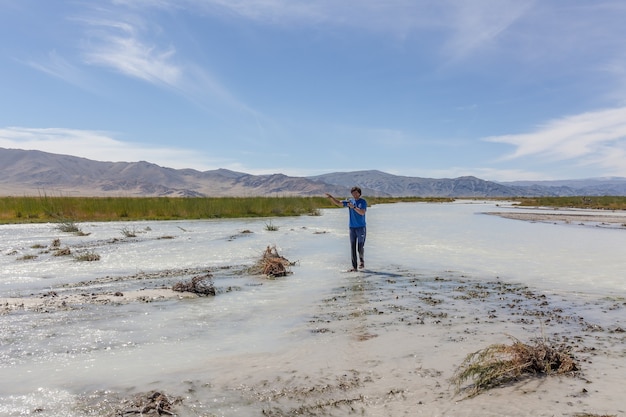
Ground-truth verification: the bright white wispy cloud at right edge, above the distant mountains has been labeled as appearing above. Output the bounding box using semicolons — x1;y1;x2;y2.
485;107;626;175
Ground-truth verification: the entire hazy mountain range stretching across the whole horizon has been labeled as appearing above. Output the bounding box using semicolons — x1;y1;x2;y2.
0;148;626;197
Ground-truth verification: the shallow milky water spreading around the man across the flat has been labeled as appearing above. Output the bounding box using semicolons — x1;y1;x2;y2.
0;201;626;416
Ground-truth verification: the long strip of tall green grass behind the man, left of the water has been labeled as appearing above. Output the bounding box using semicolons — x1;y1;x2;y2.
0;196;453;224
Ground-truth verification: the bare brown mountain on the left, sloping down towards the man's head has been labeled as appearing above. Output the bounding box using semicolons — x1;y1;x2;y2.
0;148;343;197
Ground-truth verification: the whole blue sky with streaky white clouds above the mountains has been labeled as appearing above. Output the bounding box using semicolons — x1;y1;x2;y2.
0;0;626;181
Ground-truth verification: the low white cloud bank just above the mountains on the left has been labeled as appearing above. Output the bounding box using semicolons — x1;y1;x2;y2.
0;127;224;171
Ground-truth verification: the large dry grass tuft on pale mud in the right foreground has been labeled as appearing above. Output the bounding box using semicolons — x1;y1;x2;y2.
452;338;578;397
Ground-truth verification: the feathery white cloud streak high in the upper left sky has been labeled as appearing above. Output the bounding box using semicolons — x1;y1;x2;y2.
73;6;259;117
